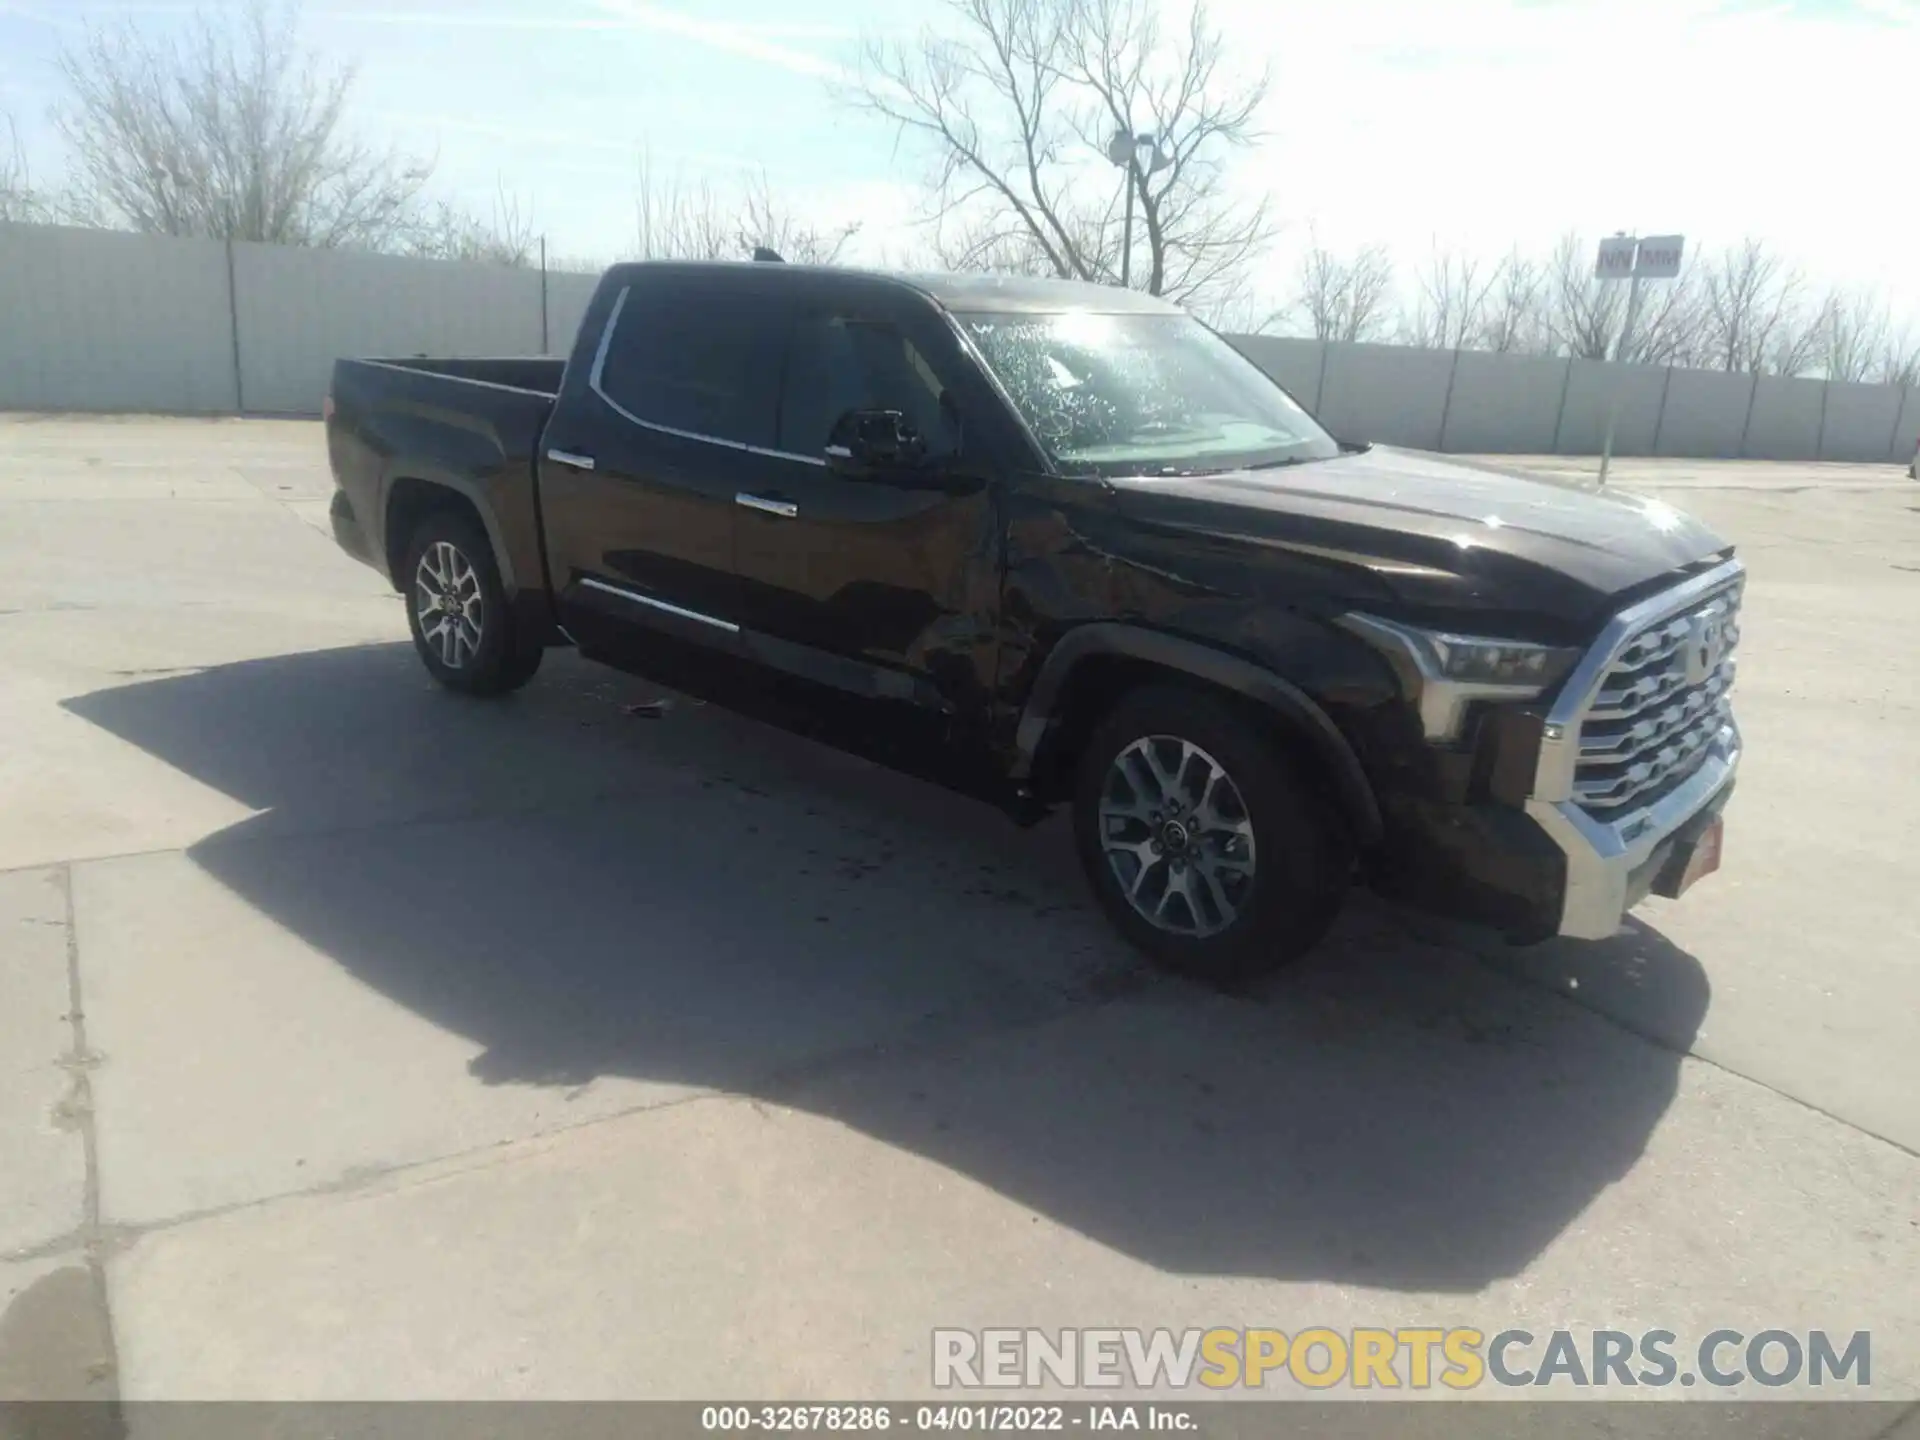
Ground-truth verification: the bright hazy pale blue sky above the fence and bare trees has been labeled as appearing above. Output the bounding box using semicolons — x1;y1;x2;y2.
0;0;1920;328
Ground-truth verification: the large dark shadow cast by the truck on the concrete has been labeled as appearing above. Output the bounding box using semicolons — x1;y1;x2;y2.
67;645;1709;1292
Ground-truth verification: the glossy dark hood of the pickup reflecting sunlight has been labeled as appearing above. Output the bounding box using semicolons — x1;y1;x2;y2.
1112;447;1730;624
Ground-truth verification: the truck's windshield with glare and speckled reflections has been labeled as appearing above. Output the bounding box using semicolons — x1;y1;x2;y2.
958;311;1340;476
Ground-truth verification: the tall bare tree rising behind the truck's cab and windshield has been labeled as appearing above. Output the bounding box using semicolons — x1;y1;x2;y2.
847;0;1273;303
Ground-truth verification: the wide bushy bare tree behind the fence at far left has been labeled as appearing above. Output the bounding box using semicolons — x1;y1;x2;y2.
56;0;430;248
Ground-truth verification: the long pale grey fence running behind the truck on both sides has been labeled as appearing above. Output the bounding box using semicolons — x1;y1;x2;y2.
0;225;1920;465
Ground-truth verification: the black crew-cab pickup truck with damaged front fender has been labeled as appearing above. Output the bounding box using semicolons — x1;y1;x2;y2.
326;263;1743;981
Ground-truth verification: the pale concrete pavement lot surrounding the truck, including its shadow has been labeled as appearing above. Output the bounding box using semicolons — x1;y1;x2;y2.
0;419;1920;1398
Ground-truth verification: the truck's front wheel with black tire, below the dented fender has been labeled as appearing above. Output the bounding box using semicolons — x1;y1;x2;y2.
1073;685;1354;987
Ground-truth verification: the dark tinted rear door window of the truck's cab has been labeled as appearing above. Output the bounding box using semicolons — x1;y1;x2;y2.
599;282;789;447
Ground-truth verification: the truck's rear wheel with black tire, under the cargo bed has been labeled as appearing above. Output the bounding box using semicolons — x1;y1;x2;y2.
399;509;545;695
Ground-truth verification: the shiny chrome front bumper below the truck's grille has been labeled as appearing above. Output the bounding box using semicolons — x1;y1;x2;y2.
1526;724;1740;941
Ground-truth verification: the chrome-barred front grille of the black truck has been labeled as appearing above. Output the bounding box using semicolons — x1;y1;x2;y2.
1572;580;1741;820
